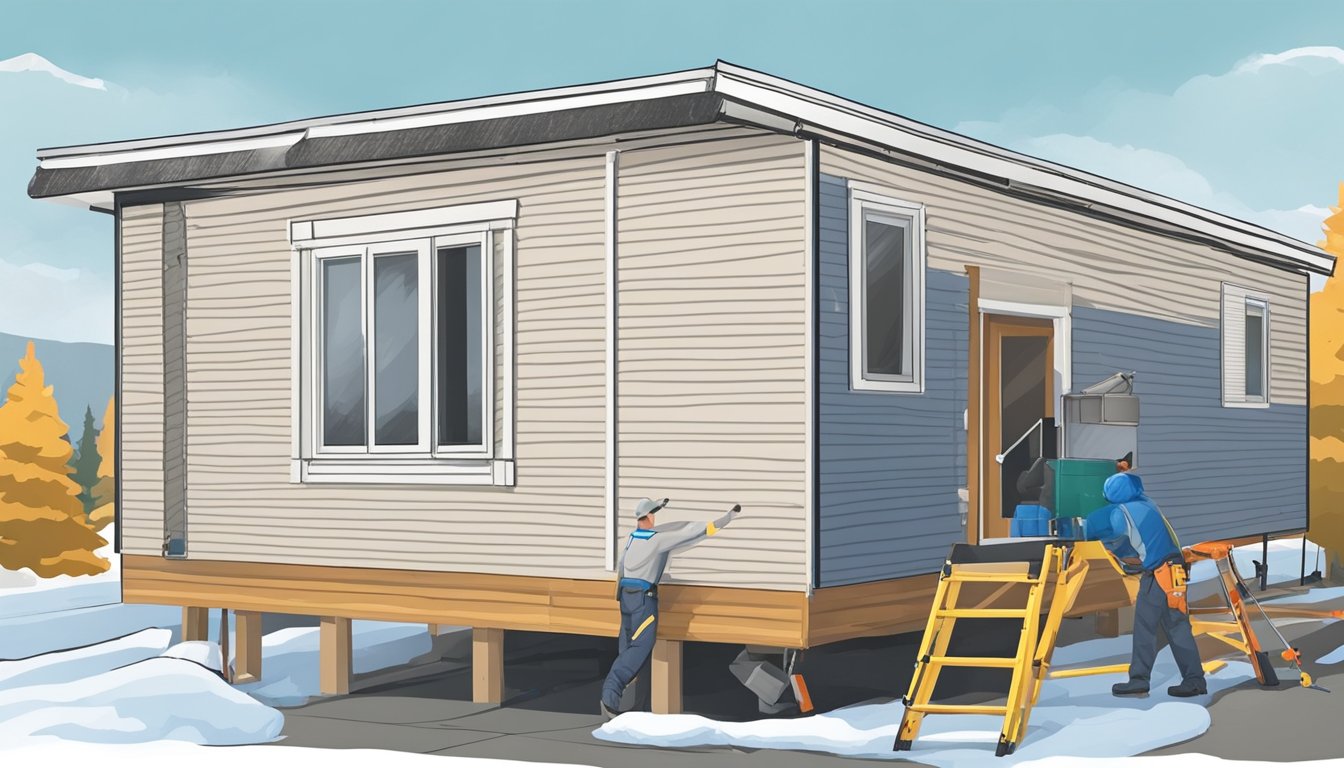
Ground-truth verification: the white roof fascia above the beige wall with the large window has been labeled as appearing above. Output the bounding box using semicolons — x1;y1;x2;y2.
36;69;714;168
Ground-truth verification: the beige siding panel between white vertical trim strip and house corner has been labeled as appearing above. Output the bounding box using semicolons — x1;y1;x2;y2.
612;136;809;589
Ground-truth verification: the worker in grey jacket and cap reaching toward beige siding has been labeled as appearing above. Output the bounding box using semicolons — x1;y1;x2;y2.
601;499;742;720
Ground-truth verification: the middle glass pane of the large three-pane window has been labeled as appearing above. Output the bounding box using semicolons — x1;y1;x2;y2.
374;253;419;445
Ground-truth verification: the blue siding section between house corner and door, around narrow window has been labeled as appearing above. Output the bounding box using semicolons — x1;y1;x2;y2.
818;176;969;586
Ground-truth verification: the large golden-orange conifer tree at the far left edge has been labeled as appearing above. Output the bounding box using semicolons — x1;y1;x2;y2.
0;342;110;578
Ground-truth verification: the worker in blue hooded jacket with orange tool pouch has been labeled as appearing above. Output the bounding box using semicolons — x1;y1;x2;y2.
1085;471;1208;697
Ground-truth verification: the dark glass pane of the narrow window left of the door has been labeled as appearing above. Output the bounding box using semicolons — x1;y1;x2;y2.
863;219;910;377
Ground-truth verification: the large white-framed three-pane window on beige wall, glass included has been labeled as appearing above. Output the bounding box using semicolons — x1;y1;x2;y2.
290;200;516;484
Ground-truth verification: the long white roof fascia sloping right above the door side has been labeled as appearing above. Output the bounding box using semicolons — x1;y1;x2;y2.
715;63;1333;274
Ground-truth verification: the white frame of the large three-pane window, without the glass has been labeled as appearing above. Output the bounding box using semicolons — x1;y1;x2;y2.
289;200;517;486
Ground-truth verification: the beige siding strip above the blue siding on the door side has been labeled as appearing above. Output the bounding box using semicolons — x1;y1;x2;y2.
821;148;1306;405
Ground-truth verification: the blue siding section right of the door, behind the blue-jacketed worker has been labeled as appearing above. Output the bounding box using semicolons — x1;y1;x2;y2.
1074;307;1306;545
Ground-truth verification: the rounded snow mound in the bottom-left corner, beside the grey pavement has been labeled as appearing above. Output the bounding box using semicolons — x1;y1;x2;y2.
0;658;284;747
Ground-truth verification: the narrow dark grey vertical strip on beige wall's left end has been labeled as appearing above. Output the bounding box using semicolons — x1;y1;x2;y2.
163;203;187;551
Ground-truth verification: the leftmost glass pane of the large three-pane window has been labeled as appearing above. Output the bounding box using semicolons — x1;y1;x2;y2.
321;257;364;445
